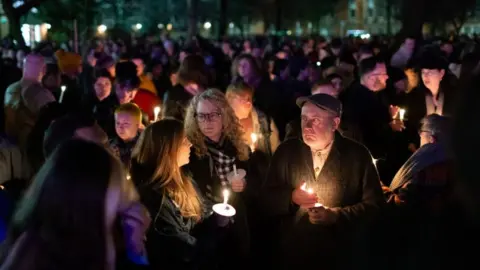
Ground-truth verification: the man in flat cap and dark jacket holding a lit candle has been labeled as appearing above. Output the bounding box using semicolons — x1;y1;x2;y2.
260;94;384;269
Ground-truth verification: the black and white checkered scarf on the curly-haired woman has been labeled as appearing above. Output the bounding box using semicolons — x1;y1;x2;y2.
207;138;235;185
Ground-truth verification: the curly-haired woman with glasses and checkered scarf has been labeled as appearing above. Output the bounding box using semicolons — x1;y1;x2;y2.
184;89;250;269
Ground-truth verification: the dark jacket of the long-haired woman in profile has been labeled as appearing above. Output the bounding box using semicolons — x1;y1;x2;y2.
131;162;225;269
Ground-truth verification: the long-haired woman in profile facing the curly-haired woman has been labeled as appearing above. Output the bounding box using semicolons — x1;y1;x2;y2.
131;119;228;269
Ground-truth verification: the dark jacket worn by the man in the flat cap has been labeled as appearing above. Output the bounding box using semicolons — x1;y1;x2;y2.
260;133;384;269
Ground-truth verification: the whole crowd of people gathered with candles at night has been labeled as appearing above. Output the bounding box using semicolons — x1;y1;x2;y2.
0;33;480;270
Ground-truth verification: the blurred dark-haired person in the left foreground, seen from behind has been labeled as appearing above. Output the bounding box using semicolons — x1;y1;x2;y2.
0;140;148;270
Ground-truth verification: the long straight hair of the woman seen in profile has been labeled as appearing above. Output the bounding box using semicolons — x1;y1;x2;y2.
132;118;202;221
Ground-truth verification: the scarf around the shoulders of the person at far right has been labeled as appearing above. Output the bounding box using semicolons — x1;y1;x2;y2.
390;143;450;191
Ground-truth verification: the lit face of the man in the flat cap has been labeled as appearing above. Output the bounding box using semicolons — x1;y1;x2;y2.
302;102;340;149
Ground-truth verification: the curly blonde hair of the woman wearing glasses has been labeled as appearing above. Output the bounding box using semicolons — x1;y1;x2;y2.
184;89;249;161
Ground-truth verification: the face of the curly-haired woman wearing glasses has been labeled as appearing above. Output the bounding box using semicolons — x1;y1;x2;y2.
195;100;223;142
